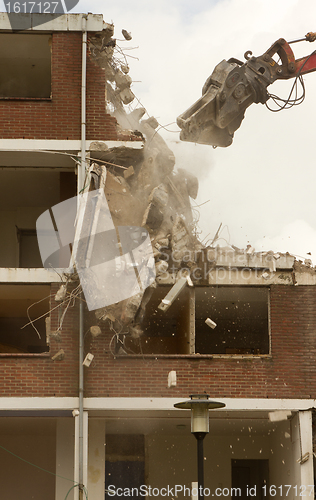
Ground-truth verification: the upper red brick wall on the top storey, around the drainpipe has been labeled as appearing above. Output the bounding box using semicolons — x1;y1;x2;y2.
0;32;117;141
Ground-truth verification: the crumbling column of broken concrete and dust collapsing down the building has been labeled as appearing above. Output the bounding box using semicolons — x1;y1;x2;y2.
89;25;201;346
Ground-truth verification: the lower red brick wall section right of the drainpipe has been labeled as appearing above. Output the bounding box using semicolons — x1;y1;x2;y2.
86;286;316;398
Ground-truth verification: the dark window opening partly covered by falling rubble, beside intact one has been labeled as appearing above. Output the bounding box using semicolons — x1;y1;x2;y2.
127;286;191;354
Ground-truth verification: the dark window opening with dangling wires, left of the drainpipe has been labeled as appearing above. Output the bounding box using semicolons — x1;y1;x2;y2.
0;285;50;353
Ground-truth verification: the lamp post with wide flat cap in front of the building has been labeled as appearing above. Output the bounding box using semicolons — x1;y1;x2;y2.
174;394;226;500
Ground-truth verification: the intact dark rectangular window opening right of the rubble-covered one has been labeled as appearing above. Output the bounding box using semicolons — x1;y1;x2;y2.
195;286;269;355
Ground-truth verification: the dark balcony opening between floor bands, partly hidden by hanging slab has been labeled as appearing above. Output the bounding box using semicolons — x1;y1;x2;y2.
0;169;76;268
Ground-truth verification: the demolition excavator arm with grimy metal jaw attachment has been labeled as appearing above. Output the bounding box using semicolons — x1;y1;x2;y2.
177;33;316;147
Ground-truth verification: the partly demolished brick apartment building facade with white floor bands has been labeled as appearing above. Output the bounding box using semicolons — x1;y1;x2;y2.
0;9;316;500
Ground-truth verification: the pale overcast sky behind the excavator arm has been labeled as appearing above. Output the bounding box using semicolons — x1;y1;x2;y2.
9;0;316;263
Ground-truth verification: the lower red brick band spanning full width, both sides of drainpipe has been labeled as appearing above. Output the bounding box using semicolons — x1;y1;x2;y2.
0;286;316;398
